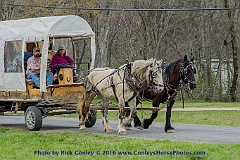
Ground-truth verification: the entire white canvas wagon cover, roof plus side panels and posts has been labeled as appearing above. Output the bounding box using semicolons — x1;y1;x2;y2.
0;15;95;91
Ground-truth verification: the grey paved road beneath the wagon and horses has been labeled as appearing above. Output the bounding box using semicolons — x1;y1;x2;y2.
0;116;240;144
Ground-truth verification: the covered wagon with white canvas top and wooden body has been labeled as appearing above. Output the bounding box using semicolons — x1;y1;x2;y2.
0;15;96;130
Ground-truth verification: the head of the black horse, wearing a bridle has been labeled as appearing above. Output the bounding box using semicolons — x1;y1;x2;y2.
180;55;197;90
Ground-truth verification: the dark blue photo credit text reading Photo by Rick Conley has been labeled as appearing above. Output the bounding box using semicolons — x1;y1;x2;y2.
34;150;206;156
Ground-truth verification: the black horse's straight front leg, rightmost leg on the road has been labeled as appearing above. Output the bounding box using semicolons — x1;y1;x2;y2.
165;100;175;133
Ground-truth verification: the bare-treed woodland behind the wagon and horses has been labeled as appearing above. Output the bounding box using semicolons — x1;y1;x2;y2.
0;0;240;102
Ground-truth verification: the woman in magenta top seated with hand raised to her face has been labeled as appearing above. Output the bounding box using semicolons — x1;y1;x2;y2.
51;45;75;80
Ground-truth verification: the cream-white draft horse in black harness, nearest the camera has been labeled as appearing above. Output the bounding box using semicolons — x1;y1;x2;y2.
76;59;164;134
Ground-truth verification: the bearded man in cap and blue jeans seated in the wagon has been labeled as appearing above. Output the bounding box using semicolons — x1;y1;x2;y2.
26;47;53;88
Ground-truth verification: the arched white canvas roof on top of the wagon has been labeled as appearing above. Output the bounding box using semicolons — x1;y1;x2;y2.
0;15;94;41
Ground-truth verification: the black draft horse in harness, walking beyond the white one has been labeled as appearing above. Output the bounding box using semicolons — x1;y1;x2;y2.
130;55;196;133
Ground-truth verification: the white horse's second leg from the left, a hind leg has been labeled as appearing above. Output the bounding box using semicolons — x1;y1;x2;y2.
102;98;113;133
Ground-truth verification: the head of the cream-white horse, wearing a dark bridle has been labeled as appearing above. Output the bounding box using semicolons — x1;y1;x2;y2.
148;59;164;92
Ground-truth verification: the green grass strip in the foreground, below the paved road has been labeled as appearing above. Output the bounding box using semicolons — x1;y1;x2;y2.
0;127;240;160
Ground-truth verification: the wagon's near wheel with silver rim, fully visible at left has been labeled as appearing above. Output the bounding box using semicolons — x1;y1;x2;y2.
25;106;42;131
